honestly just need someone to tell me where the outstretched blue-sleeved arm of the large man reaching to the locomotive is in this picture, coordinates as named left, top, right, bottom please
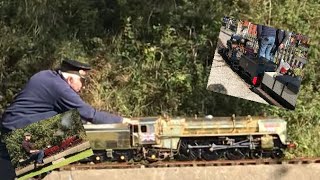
left=57, top=88, right=123, bottom=124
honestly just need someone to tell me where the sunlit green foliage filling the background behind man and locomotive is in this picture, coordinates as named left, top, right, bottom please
left=0, top=0, right=320, bottom=156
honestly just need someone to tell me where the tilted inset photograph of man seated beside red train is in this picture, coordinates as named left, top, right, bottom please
left=5, top=110, right=93, bottom=179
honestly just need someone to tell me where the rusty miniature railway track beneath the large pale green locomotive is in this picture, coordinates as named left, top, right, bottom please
left=59, top=158, right=320, bottom=171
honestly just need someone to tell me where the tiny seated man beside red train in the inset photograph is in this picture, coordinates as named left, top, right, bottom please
left=22, top=132, right=44, bottom=166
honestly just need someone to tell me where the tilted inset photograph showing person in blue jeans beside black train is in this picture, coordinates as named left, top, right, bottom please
left=207, top=17, right=310, bottom=110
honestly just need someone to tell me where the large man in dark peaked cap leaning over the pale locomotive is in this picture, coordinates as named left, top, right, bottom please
left=0, top=59, right=130, bottom=179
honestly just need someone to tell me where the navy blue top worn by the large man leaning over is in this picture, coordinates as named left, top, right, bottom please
left=2, top=70, right=122, bottom=130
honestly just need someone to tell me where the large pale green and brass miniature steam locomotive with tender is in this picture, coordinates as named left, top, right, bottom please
left=84, top=116, right=292, bottom=162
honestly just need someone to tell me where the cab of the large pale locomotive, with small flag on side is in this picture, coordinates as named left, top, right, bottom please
left=130, top=118, right=157, bottom=146
